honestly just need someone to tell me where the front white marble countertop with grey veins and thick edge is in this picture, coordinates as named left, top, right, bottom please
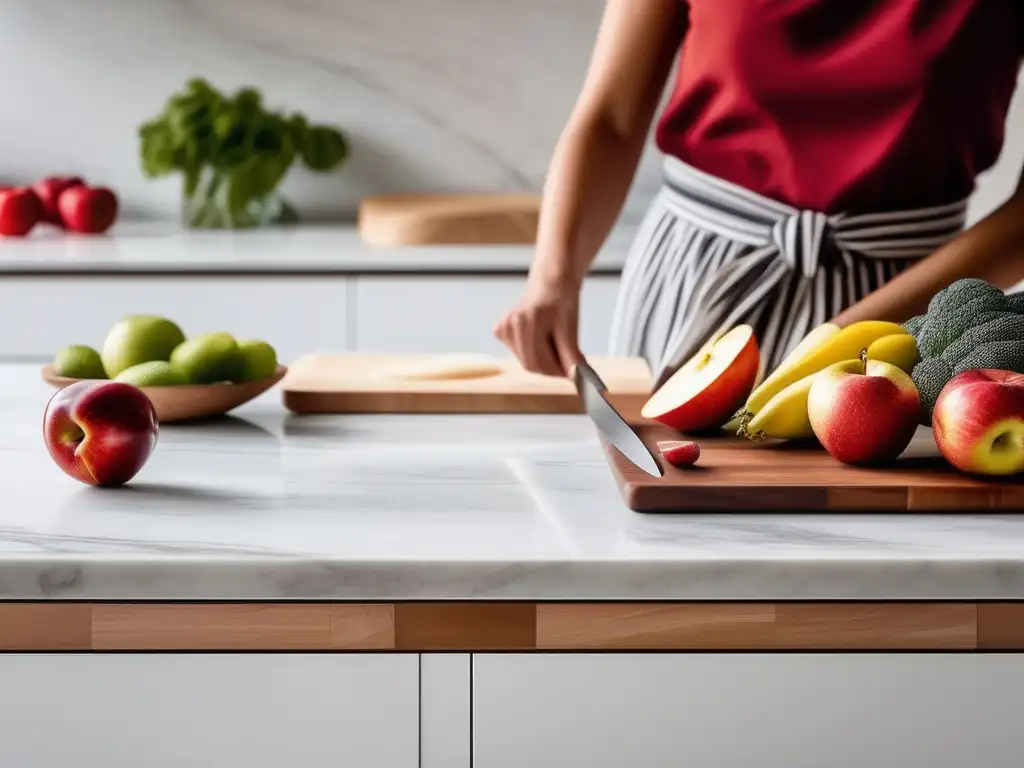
left=6, top=366, right=1024, bottom=600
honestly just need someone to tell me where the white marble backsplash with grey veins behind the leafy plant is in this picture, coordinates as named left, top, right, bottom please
left=0, top=0, right=1024, bottom=229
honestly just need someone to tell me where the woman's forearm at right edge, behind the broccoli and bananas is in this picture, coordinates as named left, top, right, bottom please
left=833, top=166, right=1024, bottom=327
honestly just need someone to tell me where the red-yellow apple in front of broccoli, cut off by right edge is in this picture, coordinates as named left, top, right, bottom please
left=932, top=369, right=1024, bottom=475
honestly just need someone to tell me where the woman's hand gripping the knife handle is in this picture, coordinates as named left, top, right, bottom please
left=495, top=278, right=583, bottom=376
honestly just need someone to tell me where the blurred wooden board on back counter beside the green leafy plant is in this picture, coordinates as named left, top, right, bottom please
left=358, top=195, right=541, bottom=246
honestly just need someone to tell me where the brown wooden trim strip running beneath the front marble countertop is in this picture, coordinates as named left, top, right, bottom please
left=0, top=601, right=1024, bottom=652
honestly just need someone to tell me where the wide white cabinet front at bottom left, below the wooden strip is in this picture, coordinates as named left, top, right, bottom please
left=0, top=654, right=419, bottom=768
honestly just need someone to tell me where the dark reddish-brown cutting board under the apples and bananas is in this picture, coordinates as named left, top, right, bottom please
left=605, top=425, right=1024, bottom=512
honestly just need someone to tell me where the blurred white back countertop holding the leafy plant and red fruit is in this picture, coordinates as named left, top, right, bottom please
left=0, top=223, right=632, bottom=275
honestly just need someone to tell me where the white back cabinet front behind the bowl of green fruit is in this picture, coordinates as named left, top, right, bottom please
left=0, top=275, right=349, bottom=364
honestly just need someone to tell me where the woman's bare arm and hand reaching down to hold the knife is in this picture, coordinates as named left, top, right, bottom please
left=495, top=0, right=686, bottom=376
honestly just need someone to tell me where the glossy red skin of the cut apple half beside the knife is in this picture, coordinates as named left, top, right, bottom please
left=645, top=333, right=761, bottom=432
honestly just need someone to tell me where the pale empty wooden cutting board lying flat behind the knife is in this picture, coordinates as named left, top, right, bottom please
left=281, top=354, right=651, bottom=419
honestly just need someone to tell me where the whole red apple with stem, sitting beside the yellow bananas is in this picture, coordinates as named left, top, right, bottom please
left=807, top=360, right=921, bottom=464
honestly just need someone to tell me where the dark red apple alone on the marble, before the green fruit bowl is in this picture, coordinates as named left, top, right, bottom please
left=43, top=381, right=159, bottom=485
